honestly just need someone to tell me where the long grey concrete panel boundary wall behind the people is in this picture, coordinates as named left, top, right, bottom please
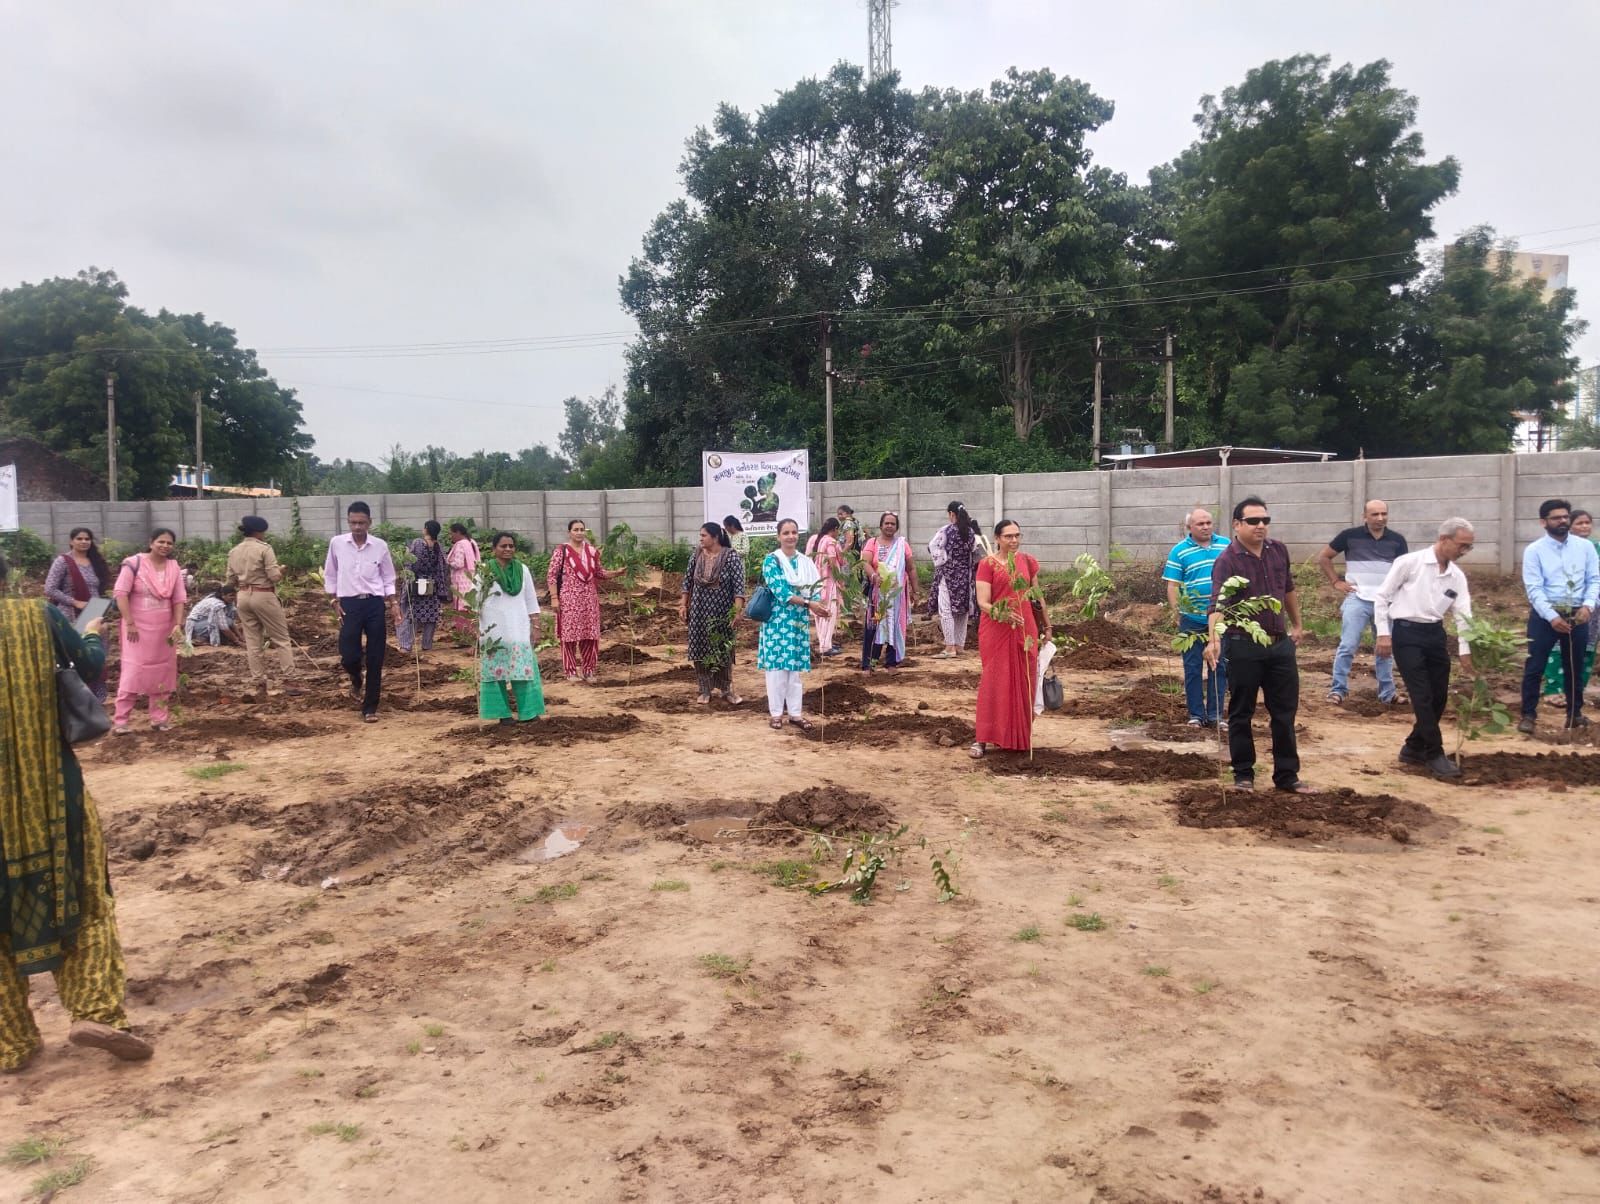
left=21, top=452, right=1600, bottom=572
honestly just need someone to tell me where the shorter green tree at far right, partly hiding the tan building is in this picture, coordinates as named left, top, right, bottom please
left=1401, top=226, right=1587, bottom=455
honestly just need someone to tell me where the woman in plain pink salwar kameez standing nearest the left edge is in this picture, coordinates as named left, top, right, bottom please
left=112, top=527, right=189, bottom=736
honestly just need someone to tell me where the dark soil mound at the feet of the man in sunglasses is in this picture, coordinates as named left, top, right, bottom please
left=1171, top=786, right=1443, bottom=844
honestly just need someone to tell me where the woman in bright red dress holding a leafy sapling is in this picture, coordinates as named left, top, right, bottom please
left=971, top=519, right=1050, bottom=757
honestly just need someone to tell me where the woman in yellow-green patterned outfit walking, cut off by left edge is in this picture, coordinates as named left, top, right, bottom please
left=0, top=557, right=150, bottom=1071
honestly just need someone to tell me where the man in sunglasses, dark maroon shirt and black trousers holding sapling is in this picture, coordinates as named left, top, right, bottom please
left=1205, top=498, right=1315, bottom=794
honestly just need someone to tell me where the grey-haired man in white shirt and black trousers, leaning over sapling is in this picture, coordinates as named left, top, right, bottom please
left=1373, top=519, right=1475, bottom=778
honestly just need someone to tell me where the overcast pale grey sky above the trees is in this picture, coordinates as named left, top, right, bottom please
left=0, top=0, right=1600, bottom=461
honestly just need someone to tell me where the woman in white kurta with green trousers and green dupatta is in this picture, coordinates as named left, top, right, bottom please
left=478, top=532, right=544, bottom=724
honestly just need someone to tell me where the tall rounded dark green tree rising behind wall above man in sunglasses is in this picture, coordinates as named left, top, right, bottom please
left=1149, top=54, right=1459, bottom=455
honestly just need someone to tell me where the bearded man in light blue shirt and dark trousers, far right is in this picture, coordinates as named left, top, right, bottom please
left=1517, top=498, right=1600, bottom=735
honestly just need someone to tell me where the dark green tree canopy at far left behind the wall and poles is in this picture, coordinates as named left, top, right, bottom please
left=0, top=267, right=310, bottom=498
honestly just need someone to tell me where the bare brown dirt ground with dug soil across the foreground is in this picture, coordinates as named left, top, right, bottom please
left=0, top=585, right=1600, bottom=1204
